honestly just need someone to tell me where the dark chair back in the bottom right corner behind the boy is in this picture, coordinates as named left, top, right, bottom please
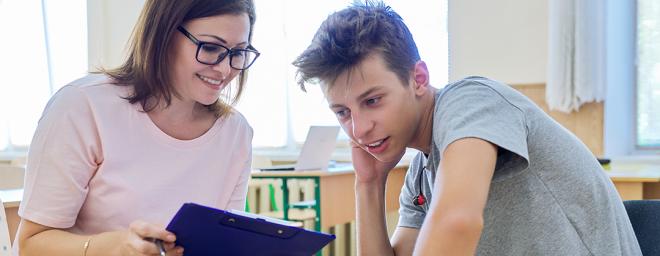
left=623, top=200, right=660, bottom=255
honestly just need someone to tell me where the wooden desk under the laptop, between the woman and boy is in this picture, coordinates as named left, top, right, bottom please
left=252, top=164, right=408, bottom=230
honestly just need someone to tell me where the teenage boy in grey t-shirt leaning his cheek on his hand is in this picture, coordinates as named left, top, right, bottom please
left=294, top=2, right=641, bottom=255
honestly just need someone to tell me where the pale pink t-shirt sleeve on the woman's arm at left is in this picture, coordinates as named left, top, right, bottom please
left=19, top=86, right=102, bottom=228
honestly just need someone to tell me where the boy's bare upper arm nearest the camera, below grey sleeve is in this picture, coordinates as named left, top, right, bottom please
left=415, top=138, right=497, bottom=255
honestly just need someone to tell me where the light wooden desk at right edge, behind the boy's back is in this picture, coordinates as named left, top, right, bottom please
left=607, top=166, right=660, bottom=200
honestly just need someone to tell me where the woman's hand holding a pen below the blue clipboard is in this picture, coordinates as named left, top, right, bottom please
left=119, top=220, right=183, bottom=256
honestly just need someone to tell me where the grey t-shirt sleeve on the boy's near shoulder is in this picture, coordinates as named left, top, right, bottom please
left=433, top=81, right=529, bottom=179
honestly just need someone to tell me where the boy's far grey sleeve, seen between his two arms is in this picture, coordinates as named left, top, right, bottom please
left=397, top=153, right=426, bottom=229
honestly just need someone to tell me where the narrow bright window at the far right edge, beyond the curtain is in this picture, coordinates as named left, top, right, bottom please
left=636, top=0, right=660, bottom=149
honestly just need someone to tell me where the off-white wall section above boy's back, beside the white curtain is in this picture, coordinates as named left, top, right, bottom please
left=448, top=0, right=548, bottom=84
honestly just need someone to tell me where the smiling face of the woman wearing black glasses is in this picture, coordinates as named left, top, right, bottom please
left=172, top=14, right=250, bottom=105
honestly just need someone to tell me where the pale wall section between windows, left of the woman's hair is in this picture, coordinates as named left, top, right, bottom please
left=87, top=0, right=144, bottom=71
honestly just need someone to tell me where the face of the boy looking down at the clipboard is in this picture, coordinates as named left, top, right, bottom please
left=322, top=54, right=420, bottom=162
